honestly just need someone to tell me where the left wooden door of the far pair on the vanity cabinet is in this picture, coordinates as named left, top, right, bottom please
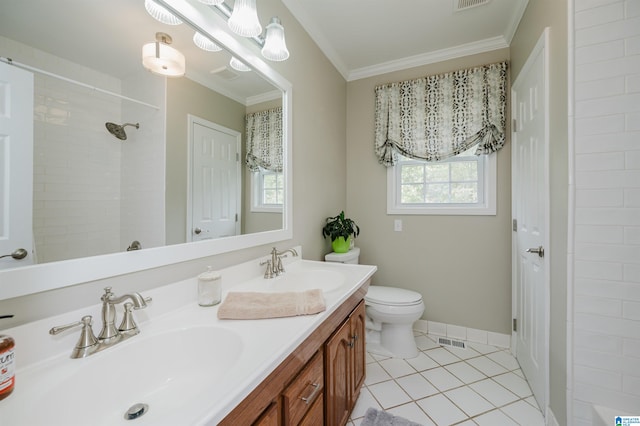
left=325, top=321, right=353, bottom=426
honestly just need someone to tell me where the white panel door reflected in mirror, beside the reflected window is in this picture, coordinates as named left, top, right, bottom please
left=187, top=117, right=241, bottom=241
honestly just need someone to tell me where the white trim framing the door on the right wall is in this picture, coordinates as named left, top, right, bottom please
left=511, top=27, right=551, bottom=419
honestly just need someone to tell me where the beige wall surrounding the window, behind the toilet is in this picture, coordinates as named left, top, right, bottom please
left=346, top=49, right=511, bottom=333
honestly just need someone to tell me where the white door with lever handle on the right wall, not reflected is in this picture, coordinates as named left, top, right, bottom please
left=511, top=30, right=549, bottom=413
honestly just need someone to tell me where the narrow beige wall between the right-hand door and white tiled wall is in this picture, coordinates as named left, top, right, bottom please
left=511, top=0, right=568, bottom=425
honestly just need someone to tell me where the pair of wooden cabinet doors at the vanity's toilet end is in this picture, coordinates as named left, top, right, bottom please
left=325, top=302, right=365, bottom=425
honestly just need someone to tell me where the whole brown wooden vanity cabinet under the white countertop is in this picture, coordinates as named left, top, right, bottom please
left=219, top=282, right=369, bottom=426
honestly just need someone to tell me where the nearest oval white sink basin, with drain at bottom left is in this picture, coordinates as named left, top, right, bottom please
left=10, top=326, right=243, bottom=426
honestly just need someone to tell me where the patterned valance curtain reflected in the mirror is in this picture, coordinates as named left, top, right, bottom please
left=245, top=107, right=282, bottom=172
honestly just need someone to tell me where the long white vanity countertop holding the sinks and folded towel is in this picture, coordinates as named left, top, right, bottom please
left=0, top=251, right=377, bottom=426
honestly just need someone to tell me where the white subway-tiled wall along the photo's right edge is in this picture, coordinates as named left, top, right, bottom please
left=568, top=0, right=640, bottom=425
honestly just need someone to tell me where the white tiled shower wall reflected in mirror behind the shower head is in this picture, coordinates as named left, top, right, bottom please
left=0, top=37, right=165, bottom=263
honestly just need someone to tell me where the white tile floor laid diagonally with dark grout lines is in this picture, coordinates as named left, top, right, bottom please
left=347, top=332, right=544, bottom=426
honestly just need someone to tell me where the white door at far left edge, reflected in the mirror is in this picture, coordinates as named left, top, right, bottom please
left=0, top=62, right=33, bottom=269
